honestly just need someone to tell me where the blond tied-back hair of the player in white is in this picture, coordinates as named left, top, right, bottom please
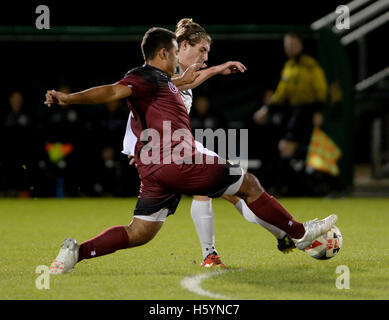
left=176, top=18, right=212, bottom=46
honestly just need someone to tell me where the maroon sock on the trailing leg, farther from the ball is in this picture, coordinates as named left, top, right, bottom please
left=78, top=226, right=128, bottom=261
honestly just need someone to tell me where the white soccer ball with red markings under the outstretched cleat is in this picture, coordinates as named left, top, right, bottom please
left=305, top=226, right=343, bottom=260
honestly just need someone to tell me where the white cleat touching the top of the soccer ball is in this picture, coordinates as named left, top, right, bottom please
left=293, top=214, right=338, bottom=250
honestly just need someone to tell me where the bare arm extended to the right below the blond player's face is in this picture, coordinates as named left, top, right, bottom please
left=176, top=61, right=247, bottom=90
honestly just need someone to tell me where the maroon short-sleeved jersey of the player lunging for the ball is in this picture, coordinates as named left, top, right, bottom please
left=117, top=65, right=196, bottom=179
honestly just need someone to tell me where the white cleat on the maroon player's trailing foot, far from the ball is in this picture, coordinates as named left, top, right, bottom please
left=50, top=238, right=80, bottom=274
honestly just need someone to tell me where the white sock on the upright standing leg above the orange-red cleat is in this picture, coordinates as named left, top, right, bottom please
left=190, top=199, right=217, bottom=259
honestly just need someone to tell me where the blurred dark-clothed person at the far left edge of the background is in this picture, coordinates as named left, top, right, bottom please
left=0, top=91, right=35, bottom=197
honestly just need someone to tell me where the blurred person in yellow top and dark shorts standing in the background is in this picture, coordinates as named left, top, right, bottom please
left=253, top=33, right=327, bottom=195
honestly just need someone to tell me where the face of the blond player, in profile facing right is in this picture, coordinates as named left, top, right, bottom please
left=178, top=39, right=211, bottom=68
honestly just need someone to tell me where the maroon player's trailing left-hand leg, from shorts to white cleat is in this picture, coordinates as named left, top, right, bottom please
left=50, top=175, right=180, bottom=274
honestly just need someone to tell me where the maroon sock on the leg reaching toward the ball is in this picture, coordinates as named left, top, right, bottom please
left=248, top=192, right=305, bottom=239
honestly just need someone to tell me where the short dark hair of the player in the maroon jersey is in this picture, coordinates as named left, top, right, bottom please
left=141, top=27, right=176, bottom=61
